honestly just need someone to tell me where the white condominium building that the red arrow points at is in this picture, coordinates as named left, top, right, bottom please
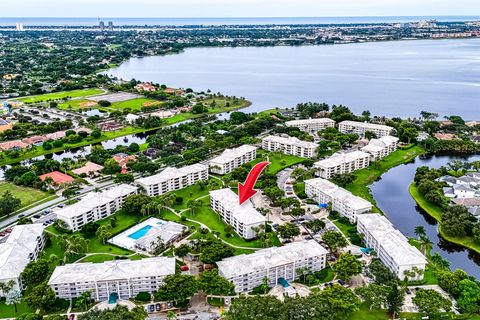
left=210, top=189, right=267, bottom=239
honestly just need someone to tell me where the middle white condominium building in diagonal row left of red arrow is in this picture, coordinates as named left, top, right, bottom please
left=136, top=163, right=208, bottom=196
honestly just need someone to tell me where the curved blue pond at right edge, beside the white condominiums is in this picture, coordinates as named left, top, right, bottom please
left=371, top=156, right=480, bottom=279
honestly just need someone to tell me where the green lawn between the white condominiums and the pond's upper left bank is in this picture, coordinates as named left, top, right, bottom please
left=346, top=145, right=425, bottom=212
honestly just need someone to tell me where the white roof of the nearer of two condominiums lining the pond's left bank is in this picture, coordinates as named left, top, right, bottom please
left=357, top=213, right=427, bottom=265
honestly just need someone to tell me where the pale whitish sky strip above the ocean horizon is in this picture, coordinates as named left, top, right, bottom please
left=0, top=0, right=480, bottom=20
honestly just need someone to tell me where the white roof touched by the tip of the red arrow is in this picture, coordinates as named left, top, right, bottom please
left=210, top=188, right=267, bottom=225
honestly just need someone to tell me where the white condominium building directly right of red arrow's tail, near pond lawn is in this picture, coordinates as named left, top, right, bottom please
left=313, top=151, right=370, bottom=179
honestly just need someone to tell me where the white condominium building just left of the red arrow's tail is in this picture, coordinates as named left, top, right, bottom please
left=208, top=145, right=257, bottom=174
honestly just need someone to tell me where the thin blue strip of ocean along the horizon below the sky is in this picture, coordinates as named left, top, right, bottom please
left=0, top=15, right=480, bottom=26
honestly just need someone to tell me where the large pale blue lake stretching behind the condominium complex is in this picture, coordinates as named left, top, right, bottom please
left=108, top=39, right=480, bottom=120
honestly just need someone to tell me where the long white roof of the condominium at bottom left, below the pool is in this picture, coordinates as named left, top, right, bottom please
left=48, top=257, right=175, bottom=285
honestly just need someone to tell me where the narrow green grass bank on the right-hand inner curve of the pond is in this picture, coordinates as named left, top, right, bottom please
left=409, top=183, right=480, bottom=253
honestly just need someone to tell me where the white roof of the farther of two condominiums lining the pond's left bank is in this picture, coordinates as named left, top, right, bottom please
left=305, top=178, right=373, bottom=210
